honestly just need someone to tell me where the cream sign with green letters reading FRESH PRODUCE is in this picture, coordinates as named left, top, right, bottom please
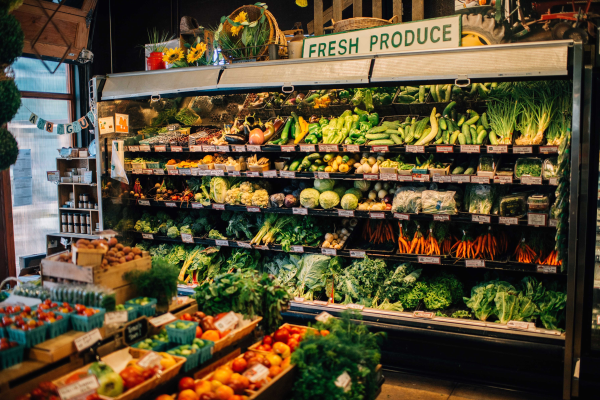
left=302, top=15, right=461, bottom=58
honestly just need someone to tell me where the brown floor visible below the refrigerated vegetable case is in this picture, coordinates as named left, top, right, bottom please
left=377, top=371, right=554, bottom=400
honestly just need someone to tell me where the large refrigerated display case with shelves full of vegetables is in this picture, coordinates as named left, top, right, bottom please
left=90, top=41, right=600, bottom=398
